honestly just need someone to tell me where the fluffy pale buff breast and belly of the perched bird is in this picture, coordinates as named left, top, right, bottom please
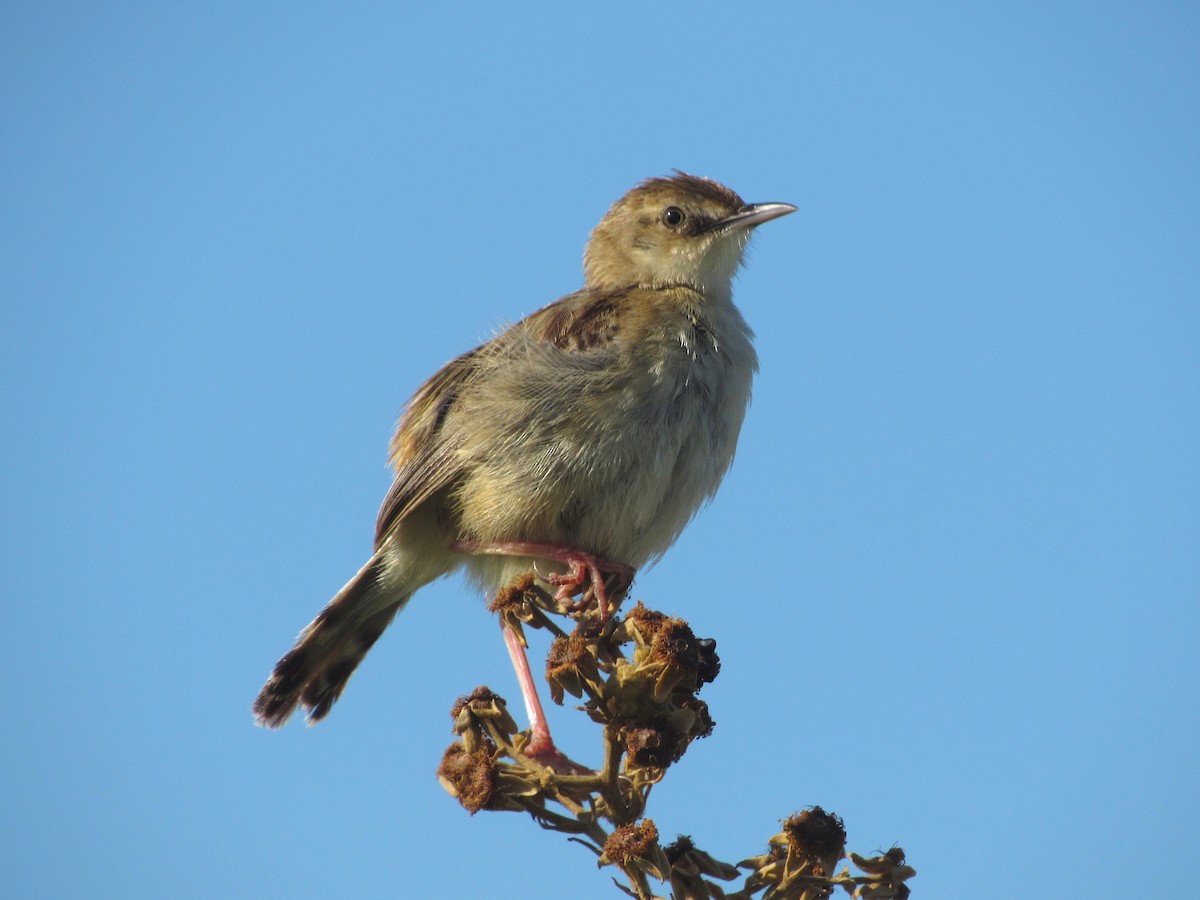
left=446, top=296, right=756, bottom=578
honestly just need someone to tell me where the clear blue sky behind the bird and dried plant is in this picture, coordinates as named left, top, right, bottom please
left=0, top=2, right=1200, bottom=898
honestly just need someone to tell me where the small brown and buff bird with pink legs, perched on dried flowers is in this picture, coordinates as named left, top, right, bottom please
left=253, top=170, right=797, bottom=766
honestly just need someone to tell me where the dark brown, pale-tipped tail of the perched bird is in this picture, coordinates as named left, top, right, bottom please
left=254, top=552, right=412, bottom=728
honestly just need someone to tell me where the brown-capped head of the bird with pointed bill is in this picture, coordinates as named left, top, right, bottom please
left=583, top=172, right=796, bottom=296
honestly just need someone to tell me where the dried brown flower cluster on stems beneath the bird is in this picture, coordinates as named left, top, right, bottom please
left=438, top=575, right=916, bottom=900
